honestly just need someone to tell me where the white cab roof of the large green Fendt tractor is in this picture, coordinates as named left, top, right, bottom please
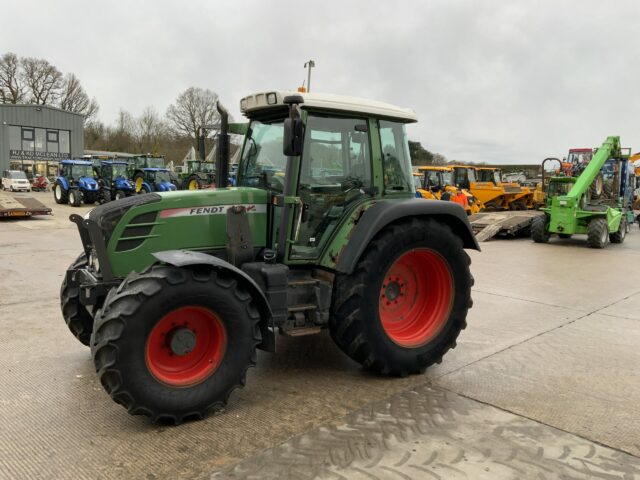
left=240, top=90, right=418, bottom=123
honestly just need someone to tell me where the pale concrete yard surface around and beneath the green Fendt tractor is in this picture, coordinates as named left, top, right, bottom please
left=0, top=192, right=640, bottom=480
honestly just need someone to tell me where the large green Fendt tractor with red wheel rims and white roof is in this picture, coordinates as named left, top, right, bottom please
left=61, top=92, right=479, bottom=423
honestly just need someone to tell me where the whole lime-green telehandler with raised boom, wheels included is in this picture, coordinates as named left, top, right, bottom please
left=531, top=136, right=634, bottom=248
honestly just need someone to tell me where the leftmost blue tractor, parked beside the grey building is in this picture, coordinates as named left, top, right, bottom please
left=53, top=160, right=100, bottom=207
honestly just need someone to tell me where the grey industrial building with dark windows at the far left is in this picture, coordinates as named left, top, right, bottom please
left=0, top=104, right=84, bottom=177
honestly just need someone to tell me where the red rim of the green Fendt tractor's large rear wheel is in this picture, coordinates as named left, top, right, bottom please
left=378, top=249, right=454, bottom=348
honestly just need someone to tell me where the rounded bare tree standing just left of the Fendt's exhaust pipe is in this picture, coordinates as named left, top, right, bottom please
left=167, top=87, right=220, bottom=148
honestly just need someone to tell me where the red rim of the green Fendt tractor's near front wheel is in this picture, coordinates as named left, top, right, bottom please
left=146, top=306, right=227, bottom=387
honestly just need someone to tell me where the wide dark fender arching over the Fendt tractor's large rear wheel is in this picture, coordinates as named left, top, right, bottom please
left=336, top=198, right=480, bottom=274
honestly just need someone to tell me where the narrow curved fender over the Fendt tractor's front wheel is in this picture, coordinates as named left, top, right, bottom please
left=152, top=250, right=276, bottom=352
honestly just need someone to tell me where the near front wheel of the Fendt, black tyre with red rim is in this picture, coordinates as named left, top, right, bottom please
left=91, top=265, right=261, bottom=424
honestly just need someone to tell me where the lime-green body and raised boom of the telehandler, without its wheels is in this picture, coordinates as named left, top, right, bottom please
left=540, top=136, right=625, bottom=235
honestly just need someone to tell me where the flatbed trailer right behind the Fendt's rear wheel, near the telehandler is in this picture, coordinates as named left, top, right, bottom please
left=469, top=210, right=544, bottom=242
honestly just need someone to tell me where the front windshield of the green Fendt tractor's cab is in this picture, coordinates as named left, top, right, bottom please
left=238, top=119, right=286, bottom=192
